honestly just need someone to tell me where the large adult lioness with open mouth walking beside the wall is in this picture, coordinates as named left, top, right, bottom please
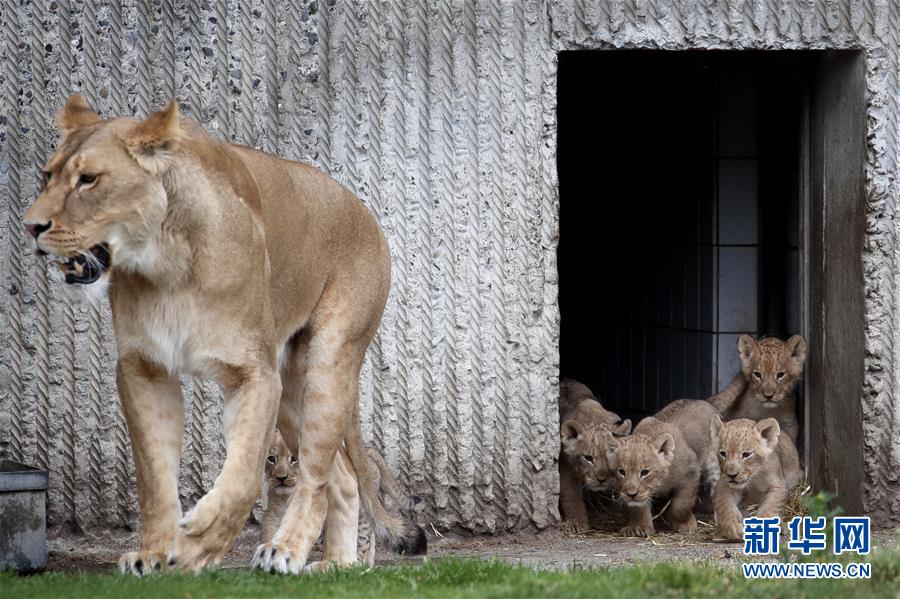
left=24, top=95, right=424, bottom=574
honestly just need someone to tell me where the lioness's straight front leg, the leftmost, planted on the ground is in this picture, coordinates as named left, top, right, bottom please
left=116, top=356, right=184, bottom=576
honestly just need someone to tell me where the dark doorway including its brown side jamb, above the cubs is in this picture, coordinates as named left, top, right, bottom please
left=557, top=50, right=865, bottom=513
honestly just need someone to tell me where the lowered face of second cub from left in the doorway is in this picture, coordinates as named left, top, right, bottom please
left=606, top=426, right=675, bottom=506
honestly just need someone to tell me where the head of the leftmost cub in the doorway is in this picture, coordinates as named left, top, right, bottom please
left=559, top=419, right=631, bottom=491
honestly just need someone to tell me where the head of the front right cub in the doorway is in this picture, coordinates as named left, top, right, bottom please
left=710, top=414, right=781, bottom=489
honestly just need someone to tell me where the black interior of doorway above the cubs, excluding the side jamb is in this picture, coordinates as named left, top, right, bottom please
left=558, top=51, right=806, bottom=424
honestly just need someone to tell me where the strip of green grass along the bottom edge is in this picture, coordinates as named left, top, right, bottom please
left=0, top=551, right=900, bottom=599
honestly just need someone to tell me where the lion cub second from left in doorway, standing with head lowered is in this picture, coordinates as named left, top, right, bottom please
left=606, top=399, right=718, bottom=537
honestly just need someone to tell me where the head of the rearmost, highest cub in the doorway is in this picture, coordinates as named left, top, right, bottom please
left=738, top=335, right=806, bottom=408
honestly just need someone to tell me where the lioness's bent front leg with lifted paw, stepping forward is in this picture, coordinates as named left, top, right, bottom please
left=169, top=364, right=281, bottom=571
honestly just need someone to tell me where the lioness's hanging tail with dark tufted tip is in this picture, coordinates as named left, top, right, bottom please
left=344, top=407, right=428, bottom=555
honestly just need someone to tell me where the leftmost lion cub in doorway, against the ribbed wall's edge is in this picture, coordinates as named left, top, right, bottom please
left=559, top=379, right=631, bottom=532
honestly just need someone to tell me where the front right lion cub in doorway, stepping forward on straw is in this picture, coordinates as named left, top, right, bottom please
left=710, top=415, right=800, bottom=540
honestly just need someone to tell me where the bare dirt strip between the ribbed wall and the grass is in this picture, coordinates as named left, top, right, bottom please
left=47, top=521, right=900, bottom=572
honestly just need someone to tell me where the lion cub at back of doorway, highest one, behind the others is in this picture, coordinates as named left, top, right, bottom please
left=709, top=335, right=806, bottom=445
